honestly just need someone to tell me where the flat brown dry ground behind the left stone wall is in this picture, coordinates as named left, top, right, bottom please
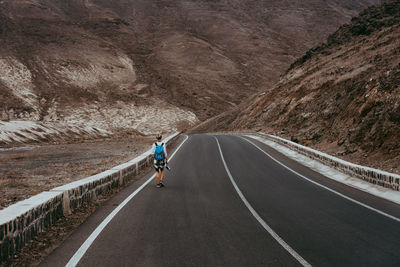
left=0, top=136, right=153, bottom=209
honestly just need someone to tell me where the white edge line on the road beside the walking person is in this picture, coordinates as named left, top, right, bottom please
left=65, top=136, right=189, bottom=267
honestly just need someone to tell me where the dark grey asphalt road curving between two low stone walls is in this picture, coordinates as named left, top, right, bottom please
left=42, top=135, right=400, bottom=266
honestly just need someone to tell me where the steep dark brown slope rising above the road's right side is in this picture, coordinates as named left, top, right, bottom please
left=197, top=1, right=400, bottom=172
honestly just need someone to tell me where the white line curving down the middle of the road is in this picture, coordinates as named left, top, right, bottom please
left=214, top=136, right=311, bottom=266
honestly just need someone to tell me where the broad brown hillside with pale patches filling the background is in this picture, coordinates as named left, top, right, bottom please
left=0, top=0, right=380, bottom=142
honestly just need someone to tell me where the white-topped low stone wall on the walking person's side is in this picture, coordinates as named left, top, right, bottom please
left=0, top=133, right=179, bottom=263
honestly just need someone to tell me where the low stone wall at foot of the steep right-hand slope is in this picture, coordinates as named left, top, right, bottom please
left=257, top=132, right=400, bottom=191
